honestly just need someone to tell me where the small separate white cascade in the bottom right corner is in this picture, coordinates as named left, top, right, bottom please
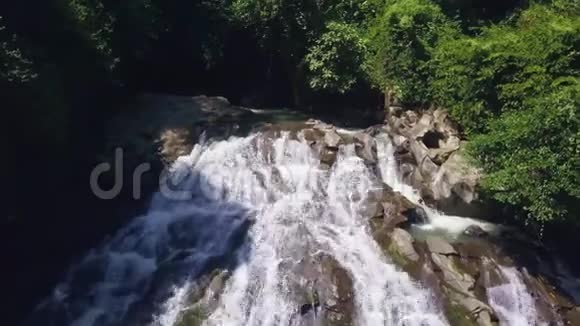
left=487, top=266, right=546, bottom=326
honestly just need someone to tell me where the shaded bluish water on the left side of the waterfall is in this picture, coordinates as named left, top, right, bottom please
left=23, top=167, right=252, bottom=326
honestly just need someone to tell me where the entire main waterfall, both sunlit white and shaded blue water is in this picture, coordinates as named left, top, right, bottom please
left=29, top=132, right=447, bottom=326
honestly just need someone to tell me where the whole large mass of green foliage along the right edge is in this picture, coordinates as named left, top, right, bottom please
left=433, top=2, right=580, bottom=223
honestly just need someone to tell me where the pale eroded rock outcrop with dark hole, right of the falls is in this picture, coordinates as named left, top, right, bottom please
left=385, top=108, right=487, bottom=217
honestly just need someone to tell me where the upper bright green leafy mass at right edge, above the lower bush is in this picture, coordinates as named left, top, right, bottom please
left=433, top=2, right=580, bottom=132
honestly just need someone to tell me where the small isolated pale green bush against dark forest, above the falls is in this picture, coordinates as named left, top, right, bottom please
left=306, top=22, right=366, bottom=93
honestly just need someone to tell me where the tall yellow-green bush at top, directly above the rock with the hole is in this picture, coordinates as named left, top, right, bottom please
left=369, top=0, right=457, bottom=103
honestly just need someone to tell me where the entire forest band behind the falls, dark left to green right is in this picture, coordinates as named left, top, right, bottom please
left=0, top=0, right=580, bottom=227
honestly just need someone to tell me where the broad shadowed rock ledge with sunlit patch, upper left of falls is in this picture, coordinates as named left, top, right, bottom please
left=98, top=94, right=255, bottom=202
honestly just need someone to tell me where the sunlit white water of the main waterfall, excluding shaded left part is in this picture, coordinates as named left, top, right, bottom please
left=152, top=133, right=446, bottom=326
